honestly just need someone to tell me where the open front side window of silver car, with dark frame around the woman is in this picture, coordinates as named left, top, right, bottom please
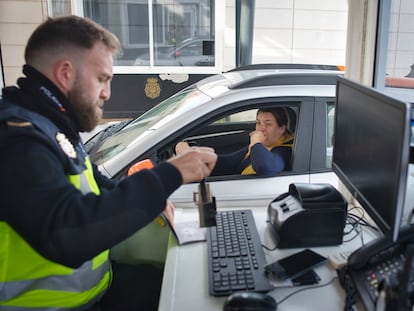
left=114, top=97, right=315, bottom=181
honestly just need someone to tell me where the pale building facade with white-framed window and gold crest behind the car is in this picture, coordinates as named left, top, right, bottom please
left=0, top=0, right=414, bottom=118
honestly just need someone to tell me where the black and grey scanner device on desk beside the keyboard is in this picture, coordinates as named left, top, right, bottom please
left=267, top=183, right=348, bottom=248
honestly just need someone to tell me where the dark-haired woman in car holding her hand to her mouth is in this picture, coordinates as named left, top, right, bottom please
left=175, top=107, right=293, bottom=176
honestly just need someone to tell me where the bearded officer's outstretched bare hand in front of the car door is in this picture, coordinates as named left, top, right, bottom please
left=168, top=147, right=217, bottom=184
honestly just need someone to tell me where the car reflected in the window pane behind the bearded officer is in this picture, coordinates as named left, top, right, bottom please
left=134, top=37, right=214, bottom=66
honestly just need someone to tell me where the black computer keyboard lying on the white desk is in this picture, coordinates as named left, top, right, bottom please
left=207, top=210, right=272, bottom=296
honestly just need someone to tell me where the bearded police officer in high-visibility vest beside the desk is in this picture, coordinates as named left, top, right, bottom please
left=0, top=16, right=216, bottom=310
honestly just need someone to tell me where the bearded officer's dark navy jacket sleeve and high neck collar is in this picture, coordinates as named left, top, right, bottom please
left=0, top=66, right=182, bottom=267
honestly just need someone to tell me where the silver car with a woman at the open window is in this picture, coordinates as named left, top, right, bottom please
left=86, top=65, right=343, bottom=208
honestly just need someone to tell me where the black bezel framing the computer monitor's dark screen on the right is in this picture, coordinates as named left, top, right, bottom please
left=332, top=76, right=411, bottom=241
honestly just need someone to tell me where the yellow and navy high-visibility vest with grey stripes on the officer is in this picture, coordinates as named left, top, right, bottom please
left=0, top=103, right=111, bottom=311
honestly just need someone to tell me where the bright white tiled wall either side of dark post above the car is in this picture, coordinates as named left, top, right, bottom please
left=223, top=0, right=348, bottom=70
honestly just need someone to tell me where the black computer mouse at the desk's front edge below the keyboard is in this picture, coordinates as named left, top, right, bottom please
left=223, top=292, right=277, bottom=311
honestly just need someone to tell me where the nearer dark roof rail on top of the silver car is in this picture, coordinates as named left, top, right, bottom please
left=228, top=73, right=341, bottom=89
